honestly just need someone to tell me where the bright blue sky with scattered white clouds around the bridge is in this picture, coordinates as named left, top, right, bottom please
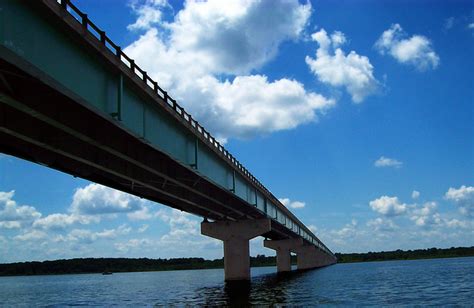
left=0, top=0, right=474, bottom=262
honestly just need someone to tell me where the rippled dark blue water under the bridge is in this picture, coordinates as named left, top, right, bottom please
left=0, top=258, right=474, bottom=306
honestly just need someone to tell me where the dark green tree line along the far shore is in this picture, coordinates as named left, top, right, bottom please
left=0, top=247, right=474, bottom=276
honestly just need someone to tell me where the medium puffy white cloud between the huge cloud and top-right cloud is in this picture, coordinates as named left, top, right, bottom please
left=306, top=29, right=378, bottom=103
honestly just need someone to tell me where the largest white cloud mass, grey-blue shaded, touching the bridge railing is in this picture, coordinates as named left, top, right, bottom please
left=125, top=0, right=335, bottom=142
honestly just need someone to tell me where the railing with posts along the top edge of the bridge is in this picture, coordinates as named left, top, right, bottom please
left=56, top=0, right=335, bottom=258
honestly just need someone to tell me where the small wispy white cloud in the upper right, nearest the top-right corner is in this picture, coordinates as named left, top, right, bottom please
left=375, top=24, right=439, bottom=71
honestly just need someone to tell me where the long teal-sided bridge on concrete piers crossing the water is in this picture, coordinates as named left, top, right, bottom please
left=0, top=0, right=336, bottom=280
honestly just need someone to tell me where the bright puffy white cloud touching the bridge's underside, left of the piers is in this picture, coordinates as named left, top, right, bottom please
left=70, top=183, right=145, bottom=215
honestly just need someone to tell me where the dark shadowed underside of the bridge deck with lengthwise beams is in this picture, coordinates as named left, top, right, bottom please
left=0, top=47, right=297, bottom=239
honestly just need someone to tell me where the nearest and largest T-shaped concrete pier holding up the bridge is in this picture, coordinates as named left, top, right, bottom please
left=201, top=218, right=271, bottom=281
